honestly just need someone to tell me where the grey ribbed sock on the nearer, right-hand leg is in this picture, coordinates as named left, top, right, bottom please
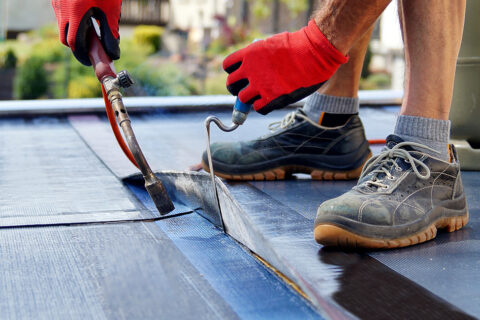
left=394, top=115, right=450, bottom=161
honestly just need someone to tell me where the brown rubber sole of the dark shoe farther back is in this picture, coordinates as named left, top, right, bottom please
left=202, top=153, right=372, bottom=181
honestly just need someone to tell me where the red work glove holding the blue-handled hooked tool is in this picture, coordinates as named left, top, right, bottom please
left=223, top=20, right=348, bottom=114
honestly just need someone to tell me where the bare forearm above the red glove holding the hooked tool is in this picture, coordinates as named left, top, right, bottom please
left=315, top=0, right=391, bottom=54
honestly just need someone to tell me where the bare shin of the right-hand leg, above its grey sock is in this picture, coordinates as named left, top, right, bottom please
left=398, top=0, right=465, bottom=120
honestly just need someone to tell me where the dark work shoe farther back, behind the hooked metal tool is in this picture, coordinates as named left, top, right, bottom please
left=202, top=109, right=371, bottom=180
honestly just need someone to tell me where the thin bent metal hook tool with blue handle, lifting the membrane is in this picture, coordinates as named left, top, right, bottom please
left=205, top=98, right=252, bottom=213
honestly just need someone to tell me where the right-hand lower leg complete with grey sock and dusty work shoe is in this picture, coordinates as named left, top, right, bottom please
left=314, top=0, right=468, bottom=248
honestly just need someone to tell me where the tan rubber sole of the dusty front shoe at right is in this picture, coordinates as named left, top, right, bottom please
left=314, top=212, right=468, bottom=249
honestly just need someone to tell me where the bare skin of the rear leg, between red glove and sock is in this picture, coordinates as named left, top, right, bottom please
left=318, top=25, right=373, bottom=98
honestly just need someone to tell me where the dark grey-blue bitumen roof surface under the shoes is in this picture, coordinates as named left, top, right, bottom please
left=0, top=104, right=480, bottom=319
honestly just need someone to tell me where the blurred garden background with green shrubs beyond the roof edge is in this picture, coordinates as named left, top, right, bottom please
left=0, top=0, right=404, bottom=99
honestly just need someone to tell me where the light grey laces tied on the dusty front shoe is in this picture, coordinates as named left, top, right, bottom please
left=359, top=142, right=439, bottom=189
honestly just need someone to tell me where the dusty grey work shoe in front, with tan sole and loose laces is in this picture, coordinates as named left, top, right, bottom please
left=314, top=135, right=468, bottom=248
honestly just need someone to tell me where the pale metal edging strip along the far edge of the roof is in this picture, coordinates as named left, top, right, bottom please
left=0, top=90, right=403, bottom=116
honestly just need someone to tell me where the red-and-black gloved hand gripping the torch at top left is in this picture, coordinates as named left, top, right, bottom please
left=52, top=0, right=122, bottom=66
